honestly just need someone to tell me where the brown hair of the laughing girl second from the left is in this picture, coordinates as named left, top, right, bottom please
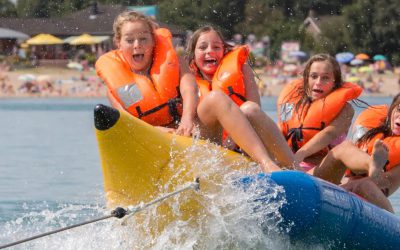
left=186, top=25, right=233, bottom=76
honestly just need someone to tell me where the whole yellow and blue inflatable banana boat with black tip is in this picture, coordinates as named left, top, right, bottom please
left=95, top=105, right=400, bottom=249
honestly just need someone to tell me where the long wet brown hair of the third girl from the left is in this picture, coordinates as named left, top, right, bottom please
left=295, top=54, right=343, bottom=111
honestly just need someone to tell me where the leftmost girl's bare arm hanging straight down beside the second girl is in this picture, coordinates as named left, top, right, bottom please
left=176, top=59, right=199, bottom=136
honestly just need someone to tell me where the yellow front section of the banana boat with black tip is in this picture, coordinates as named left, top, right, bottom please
left=94, top=104, right=251, bottom=221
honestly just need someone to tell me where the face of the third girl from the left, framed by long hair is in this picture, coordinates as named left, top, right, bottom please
left=308, top=61, right=335, bottom=101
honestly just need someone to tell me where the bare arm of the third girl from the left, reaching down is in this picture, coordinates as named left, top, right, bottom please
left=294, top=103, right=354, bottom=164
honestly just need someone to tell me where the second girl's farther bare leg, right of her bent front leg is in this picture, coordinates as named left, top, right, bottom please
left=240, top=101, right=294, bottom=168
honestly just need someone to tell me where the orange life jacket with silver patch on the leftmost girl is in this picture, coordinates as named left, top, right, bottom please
left=96, top=29, right=182, bottom=126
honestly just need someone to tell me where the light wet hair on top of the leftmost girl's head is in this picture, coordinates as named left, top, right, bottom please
left=113, top=11, right=158, bottom=46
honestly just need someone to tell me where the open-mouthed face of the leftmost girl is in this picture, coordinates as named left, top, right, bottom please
left=118, top=21, right=155, bottom=73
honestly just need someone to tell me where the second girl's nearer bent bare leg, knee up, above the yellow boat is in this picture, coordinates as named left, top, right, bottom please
left=197, top=91, right=281, bottom=172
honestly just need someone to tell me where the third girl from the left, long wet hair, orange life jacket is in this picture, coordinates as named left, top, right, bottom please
left=277, top=54, right=362, bottom=174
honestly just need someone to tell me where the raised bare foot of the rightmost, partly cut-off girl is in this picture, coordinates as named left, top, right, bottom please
left=368, top=140, right=389, bottom=179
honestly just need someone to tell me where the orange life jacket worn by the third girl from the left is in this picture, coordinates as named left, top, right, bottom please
left=277, top=79, right=362, bottom=152
